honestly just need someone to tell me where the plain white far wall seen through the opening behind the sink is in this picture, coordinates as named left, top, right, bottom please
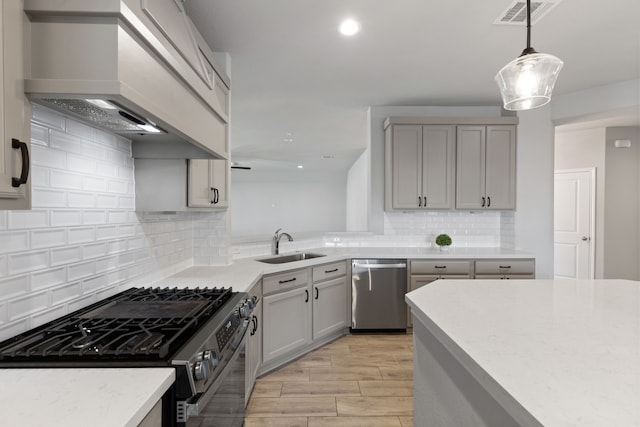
left=229, top=169, right=347, bottom=239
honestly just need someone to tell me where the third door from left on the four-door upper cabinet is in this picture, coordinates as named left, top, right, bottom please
left=456, top=126, right=486, bottom=209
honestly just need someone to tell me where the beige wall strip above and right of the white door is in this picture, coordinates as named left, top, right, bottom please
left=555, top=127, right=605, bottom=279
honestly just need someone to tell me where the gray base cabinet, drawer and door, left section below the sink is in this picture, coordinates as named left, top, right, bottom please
left=262, top=269, right=312, bottom=366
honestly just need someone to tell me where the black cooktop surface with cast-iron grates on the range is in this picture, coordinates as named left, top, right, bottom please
left=0, top=288, right=233, bottom=366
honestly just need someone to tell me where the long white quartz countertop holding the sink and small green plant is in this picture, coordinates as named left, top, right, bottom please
left=154, top=247, right=534, bottom=292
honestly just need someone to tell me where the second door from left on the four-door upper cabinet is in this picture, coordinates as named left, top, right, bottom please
left=422, top=126, right=455, bottom=209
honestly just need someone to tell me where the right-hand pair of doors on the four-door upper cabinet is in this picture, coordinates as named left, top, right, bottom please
left=456, top=125, right=516, bottom=210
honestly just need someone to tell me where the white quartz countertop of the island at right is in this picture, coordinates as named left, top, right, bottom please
left=406, top=280, right=640, bottom=427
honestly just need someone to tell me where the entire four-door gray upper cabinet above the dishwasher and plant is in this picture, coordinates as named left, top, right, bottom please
left=384, top=117, right=518, bottom=210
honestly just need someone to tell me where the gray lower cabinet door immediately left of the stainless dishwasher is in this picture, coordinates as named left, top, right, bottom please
left=313, top=276, right=347, bottom=340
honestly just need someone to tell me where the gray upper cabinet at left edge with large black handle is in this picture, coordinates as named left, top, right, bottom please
left=0, top=0, right=31, bottom=210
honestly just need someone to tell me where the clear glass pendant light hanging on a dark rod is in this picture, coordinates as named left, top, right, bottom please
left=495, top=0, right=564, bottom=111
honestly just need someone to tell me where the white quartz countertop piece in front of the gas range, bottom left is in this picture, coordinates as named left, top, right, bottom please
left=0, top=368, right=175, bottom=427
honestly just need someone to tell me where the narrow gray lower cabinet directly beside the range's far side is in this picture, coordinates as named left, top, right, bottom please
left=244, top=282, right=262, bottom=406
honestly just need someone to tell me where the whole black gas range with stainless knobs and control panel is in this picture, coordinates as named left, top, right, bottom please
left=0, top=288, right=256, bottom=426
